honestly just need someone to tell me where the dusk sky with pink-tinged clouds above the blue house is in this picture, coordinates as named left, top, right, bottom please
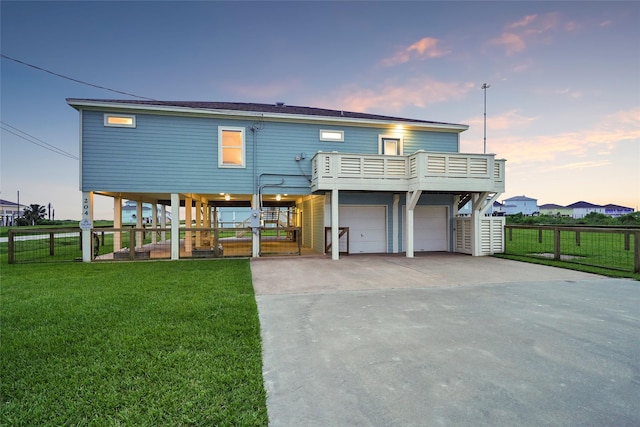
left=0, top=1, right=640, bottom=219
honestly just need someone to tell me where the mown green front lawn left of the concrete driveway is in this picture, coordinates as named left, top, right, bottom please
left=0, top=258, right=267, bottom=426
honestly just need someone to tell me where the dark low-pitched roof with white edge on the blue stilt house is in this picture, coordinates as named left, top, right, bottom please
left=67, top=98, right=469, bottom=132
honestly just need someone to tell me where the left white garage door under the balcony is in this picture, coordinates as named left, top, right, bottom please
left=338, top=206, right=387, bottom=254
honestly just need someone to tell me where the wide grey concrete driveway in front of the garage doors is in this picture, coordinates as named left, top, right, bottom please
left=251, top=254, right=640, bottom=427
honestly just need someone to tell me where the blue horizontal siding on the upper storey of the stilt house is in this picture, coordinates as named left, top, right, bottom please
left=82, top=110, right=458, bottom=194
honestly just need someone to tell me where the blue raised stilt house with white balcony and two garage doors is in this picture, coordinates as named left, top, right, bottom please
left=67, top=99, right=505, bottom=261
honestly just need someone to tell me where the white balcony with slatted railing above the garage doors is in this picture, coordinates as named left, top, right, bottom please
left=311, top=151, right=505, bottom=193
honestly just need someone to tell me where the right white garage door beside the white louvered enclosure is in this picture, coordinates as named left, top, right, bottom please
left=403, top=206, right=449, bottom=252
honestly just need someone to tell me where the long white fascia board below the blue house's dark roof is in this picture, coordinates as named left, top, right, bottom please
left=67, top=99, right=469, bottom=132
